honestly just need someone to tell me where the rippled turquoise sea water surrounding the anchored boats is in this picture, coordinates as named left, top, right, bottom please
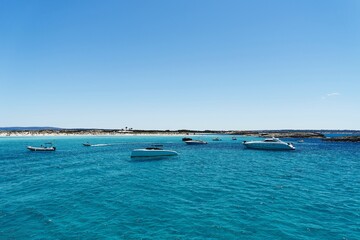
left=0, top=136, right=360, bottom=239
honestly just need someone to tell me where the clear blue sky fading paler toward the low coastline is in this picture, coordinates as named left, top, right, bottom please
left=0, top=0, right=360, bottom=129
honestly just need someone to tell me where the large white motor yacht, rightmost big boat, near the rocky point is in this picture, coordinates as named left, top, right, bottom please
left=243, top=137, right=295, bottom=150
